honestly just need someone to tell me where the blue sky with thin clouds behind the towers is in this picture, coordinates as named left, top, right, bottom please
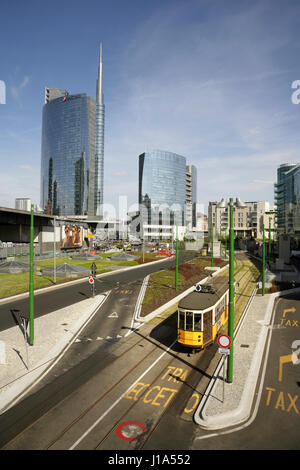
left=0, top=0, right=300, bottom=215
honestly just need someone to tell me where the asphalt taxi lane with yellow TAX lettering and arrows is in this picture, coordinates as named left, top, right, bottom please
left=193, top=294, right=300, bottom=450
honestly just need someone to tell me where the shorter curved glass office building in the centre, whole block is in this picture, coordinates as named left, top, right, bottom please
left=139, top=150, right=197, bottom=240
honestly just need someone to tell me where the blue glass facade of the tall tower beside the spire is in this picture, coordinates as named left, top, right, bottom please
left=41, top=94, right=96, bottom=215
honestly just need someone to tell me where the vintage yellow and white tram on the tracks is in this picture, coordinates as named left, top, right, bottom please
left=177, top=276, right=233, bottom=349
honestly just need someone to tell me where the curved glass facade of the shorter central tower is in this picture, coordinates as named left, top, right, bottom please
left=139, top=150, right=186, bottom=232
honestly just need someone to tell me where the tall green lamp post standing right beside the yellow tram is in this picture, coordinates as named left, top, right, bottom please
left=218, top=197, right=246, bottom=383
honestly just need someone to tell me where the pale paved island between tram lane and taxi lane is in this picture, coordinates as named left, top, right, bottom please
left=194, top=282, right=300, bottom=434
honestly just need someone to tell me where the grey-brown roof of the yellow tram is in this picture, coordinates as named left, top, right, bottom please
left=178, top=276, right=229, bottom=310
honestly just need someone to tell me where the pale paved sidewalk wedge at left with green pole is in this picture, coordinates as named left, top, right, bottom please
left=0, top=293, right=108, bottom=413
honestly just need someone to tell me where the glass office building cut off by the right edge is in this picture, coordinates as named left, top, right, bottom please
left=274, top=163, right=300, bottom=241
